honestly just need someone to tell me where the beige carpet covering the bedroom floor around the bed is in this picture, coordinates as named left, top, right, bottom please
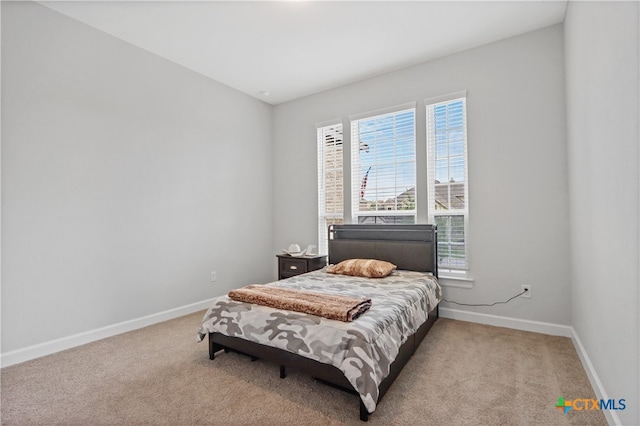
left=1, top=313, right=606, bottom=425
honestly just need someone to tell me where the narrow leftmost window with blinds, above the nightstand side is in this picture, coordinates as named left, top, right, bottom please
left=317, top=124, right=344, bottom=254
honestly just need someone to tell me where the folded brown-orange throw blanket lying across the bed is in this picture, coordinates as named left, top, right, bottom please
left=229, top=284, right=371, bottom=322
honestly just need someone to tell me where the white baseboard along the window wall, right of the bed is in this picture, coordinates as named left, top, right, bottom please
left=439, top=307, right=573, bottom=337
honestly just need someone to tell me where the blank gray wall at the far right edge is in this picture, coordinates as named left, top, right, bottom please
left=565, top=2, right=640, bottom=425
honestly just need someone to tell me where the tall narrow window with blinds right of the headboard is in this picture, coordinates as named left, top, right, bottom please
left=425, top=92, right=469, bottom=276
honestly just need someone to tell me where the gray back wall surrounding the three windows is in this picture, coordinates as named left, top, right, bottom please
left=273, top=25, right=571, bottom=325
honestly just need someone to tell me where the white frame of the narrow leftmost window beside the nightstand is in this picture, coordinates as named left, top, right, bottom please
left=316, top=120, right=345, bottom=254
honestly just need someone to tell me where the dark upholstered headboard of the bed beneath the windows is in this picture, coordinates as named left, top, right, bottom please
left=329, top=225, right=438, bottom=276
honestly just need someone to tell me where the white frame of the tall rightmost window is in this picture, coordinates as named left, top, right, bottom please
left=424, top=90, right=470, bottom=280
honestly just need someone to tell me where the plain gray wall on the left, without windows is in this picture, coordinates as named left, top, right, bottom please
left=2, top=2, right=275, bottom=353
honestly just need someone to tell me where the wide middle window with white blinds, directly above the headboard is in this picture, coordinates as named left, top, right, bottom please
left=351, top=104, right=416, bottom=223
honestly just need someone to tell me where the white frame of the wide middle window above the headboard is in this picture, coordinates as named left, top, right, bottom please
left=349, top=102, right=417, bottom=223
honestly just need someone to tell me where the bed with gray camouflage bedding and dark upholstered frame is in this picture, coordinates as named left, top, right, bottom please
left=198, top=225, right=441, bottom=421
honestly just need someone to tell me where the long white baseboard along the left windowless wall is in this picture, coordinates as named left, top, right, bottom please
left=0, top=299, right=213, bottom=367
